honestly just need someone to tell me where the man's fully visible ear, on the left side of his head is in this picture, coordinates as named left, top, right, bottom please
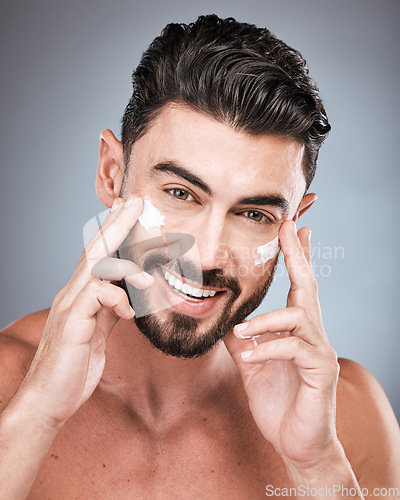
left=96, top=129, right=124, bottom=207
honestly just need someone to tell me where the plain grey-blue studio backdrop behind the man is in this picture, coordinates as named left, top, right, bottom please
left=0, top=0, right=400, bottom=418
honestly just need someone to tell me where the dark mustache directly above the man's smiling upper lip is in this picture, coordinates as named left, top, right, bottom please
left=143, top=252, right=242, bottom=300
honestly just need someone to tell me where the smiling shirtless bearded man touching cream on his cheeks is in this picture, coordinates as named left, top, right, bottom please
left=0, top=16, right=400, bottom=499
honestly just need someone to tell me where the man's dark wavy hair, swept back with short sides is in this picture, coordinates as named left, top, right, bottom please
left=122, top=15, right=331, bottom=189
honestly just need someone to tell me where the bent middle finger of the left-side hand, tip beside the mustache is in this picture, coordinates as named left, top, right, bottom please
left=89, top=257, right=154, bottom=289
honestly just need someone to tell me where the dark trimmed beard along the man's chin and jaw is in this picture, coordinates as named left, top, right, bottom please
left=135, top=259, right=278, bottom=359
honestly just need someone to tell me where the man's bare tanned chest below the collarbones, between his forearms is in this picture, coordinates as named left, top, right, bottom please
left=29, top=404, right=289, bottom=500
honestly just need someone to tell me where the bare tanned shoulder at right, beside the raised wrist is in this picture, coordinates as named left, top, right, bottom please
left=337, top=359, right=400, bottom=486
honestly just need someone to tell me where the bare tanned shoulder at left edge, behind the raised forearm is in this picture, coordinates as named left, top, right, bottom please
left=0, top=309, right=49, bottom=411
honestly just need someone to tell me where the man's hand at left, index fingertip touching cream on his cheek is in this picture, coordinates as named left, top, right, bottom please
left=16, top=197, right=154, bottom=428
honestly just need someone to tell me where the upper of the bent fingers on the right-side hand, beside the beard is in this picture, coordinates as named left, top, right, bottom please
left=233, top=306, right=330, bottom=350
